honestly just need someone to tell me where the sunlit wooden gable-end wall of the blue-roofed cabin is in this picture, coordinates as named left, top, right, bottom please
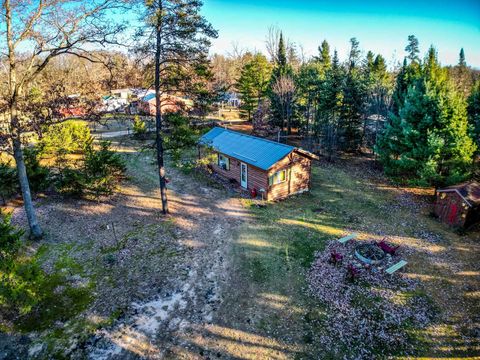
left=267, top=152, right=312, bottom=200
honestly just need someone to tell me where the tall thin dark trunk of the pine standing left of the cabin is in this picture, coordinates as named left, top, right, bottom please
left=155, top=16, right=168, bottom=214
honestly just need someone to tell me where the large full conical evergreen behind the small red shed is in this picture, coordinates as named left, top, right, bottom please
left=378, top=47, right=476, bottom=187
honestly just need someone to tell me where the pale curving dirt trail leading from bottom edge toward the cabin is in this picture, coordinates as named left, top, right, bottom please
left=87, top=168, right=246, bottom=360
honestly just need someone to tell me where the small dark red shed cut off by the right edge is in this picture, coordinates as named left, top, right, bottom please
left=435, top=181, right=480, bottom=228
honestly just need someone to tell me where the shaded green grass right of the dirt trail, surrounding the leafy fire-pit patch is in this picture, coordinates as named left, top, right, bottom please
left=224, top=159, right=480, bottom=358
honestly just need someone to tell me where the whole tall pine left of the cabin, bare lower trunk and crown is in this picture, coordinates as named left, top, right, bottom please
left=137, top=0, right=217, bottom=214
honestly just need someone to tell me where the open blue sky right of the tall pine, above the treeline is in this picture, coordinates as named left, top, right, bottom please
left=203, top=0, right=480, bottom=68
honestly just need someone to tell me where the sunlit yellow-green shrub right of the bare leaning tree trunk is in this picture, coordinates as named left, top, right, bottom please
left=39, top=120, right=91, bottom=156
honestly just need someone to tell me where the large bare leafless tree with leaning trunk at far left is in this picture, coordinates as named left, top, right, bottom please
left=0, top=0, right=124, bottom=238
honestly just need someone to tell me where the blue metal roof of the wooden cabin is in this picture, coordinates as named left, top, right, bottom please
left=200, top=127, right=295, bottom=170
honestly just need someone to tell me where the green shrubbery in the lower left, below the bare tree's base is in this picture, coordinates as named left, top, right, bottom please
left=0, top=212, right=91, bottom=331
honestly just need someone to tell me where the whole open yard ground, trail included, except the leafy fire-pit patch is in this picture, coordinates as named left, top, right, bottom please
left=0, top=139, right=480, bottom=359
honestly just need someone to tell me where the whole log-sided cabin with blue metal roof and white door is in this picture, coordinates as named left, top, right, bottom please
left=200, top=127, right=317, bottom=200
